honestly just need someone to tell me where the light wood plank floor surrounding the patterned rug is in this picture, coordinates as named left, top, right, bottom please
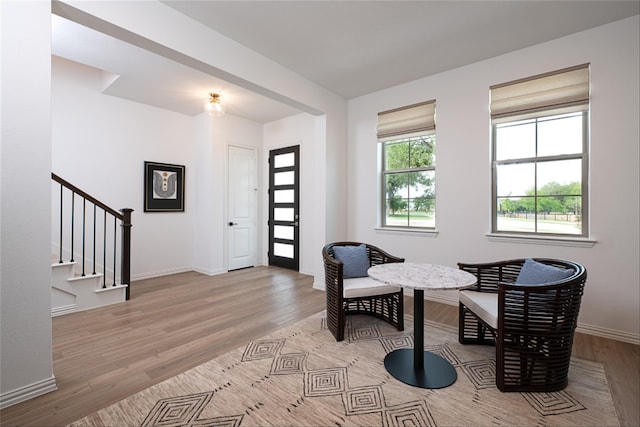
left=0, top=267, right=640, bottom=427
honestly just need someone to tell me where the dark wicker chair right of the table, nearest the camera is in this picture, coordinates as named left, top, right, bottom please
left=458, top=258, right=587, bottom=392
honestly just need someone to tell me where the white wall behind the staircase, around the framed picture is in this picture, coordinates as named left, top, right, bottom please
left=51, top=57, right=197, bottom=280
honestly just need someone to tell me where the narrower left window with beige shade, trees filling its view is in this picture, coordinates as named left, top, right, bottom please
left=378, top=101, right=436, bottom=228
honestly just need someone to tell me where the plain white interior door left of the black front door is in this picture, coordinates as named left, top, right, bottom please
left=227, top=146, right=258, bottom=270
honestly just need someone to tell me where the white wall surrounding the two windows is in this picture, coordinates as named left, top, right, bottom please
left=348, top=16, right=640, bottom=342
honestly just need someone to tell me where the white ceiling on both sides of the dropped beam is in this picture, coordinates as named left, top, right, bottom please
left=52, top=0, right=640, bottom=123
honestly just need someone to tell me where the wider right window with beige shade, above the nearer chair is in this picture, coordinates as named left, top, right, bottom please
left=491, top=65, right=589, bottom=237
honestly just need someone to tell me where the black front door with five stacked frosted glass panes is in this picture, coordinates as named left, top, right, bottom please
left=269, top=145, right=300, bottom=271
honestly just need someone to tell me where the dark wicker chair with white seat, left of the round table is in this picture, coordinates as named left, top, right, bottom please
left=322, top=242, right=404, bottom=341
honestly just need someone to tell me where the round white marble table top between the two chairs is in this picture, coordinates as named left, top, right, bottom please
left=367, top=262, right=476, bottom=290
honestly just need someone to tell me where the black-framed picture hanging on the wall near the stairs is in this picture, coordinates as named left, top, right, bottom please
left=144, top=162, right=185, bottom=212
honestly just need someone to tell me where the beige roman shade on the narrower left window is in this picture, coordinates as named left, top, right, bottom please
left=378, top=99, right=436, bottom=141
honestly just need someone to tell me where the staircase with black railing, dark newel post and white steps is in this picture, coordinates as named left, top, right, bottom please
left=51, top=173, right=133, bottom=316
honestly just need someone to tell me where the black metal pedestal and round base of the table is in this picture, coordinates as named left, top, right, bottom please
left=384, top=289, right=458, bottom=388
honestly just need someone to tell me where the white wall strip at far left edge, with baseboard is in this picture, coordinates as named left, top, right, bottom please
left=0, top=1, right=56, bottom=407
